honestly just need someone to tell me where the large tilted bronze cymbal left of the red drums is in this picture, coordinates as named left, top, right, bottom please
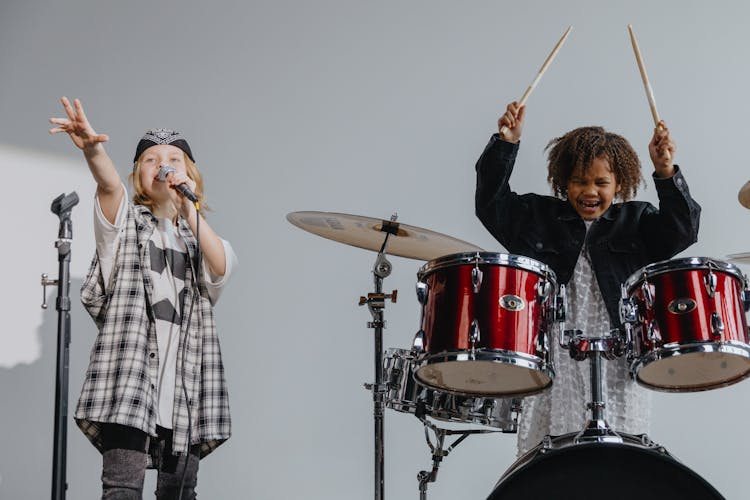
left=286, top=212, right=483, bottom=260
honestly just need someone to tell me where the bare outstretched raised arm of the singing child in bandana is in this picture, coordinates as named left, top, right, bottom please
left=49, top=97, right=124, bottom=223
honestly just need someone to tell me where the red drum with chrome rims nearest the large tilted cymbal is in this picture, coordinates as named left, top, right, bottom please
left=414, top=252, right=556, bottom=396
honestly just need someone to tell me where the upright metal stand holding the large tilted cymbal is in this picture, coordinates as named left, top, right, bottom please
left=359, top=214, right=398, bottom=500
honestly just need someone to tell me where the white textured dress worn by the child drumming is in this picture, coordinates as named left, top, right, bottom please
left=518, top=221, right=651, bottom=456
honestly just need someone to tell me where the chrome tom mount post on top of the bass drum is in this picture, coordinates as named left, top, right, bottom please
left=560, top=329, right=625, bottom=443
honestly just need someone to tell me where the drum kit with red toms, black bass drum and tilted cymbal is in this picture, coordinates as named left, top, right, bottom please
left=287, top=212, right=750, bottom=500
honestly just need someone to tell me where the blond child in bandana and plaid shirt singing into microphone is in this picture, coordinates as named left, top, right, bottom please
left=50, top=97, right=237, bottom=500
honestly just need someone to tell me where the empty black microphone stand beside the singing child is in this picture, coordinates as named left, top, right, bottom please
left=41, top=191, right=78, bottom=500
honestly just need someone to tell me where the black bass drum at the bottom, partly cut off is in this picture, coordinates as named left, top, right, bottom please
left=487, top=433, right=724, bottom=500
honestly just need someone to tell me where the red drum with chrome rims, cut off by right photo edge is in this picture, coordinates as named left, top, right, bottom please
left=623, top=257, right=750, bottom=392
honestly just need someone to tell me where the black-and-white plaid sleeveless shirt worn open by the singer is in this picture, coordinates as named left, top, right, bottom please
left=75, top=203, right=231, bottom=457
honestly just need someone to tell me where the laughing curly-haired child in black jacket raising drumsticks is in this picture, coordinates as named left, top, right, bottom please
left=475, top=102, right=701, bottom=455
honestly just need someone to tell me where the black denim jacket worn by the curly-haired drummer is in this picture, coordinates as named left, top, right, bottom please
left=475, top=134, right=701, bottom=327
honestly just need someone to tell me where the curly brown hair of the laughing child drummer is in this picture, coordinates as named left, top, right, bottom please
left=544, top=127, right=644, bottom=201
